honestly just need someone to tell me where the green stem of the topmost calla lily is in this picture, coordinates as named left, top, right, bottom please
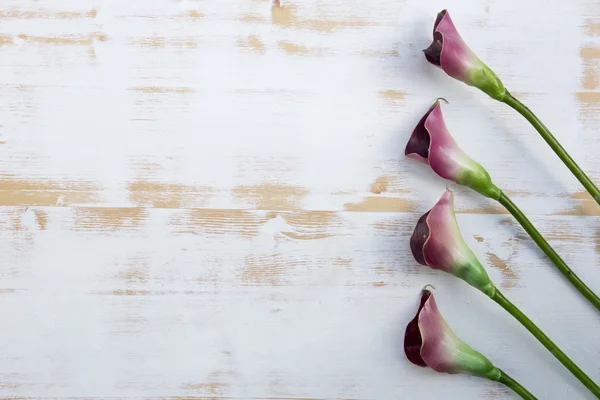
left=501, top=91, right=600, bottom=205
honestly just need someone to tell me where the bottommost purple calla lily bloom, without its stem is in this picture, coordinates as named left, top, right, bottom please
left=404, top=287, right=501, bottom=381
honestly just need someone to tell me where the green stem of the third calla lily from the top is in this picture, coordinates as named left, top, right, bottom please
left=492, top=290, right=600, bottom=399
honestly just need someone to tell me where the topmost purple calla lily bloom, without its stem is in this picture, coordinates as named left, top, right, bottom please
left=423, top=10, right=507, bottom=100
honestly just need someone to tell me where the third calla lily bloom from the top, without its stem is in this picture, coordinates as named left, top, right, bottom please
left=410, top=189, right=496, bottom=297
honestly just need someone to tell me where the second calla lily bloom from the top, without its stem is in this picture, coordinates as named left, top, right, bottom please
left=404, top=99, right=500, bottom=199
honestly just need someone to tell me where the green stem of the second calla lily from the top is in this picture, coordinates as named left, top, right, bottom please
left=497, top=192, right=600, bottom=310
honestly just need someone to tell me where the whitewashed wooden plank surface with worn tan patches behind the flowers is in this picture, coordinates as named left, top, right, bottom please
left=0, top=0, right=600, bottom=400
